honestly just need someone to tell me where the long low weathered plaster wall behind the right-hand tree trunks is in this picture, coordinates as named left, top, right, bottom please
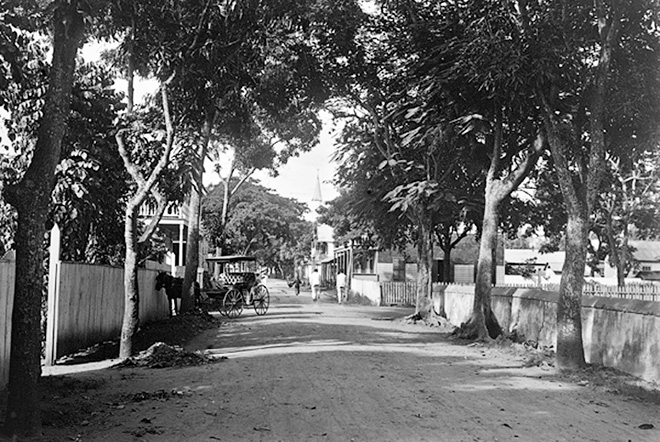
left=434, top=285, right=660, bottom=382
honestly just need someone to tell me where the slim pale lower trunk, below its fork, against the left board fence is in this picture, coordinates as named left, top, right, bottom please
left=119, top=208, right=140, bottom=359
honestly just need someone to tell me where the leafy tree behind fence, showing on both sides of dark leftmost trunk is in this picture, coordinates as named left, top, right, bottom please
left=2, top=54, right=126, bottom=263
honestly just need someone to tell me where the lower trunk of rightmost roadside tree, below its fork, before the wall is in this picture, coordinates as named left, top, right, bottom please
left=557, top=210, right=589, bottom=368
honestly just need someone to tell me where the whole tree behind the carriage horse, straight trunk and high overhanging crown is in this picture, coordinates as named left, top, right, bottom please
left=163, top=1, right=359, bottom=311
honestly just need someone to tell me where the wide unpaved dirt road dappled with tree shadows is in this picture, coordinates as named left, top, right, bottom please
left=5, top=280, right=660, bottom=442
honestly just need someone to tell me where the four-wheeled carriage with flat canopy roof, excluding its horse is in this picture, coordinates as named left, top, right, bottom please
left=202, top=255, right=270, bottom=318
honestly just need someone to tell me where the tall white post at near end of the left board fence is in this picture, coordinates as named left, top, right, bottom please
left=46, top=224, right=62, bottom=365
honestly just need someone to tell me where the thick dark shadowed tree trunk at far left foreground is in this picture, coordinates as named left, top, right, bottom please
left=5, top=1, right=84, bottom=436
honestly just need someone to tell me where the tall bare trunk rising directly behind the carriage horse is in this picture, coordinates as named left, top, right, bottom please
left=181, top=111, right=215, bottom=313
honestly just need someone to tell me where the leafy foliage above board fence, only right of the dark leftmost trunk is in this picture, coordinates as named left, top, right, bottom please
left=50, top=64, right=128, bottom=265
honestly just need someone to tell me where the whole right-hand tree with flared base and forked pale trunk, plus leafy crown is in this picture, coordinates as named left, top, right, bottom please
left=346, top=1, right=543, bottom=328
